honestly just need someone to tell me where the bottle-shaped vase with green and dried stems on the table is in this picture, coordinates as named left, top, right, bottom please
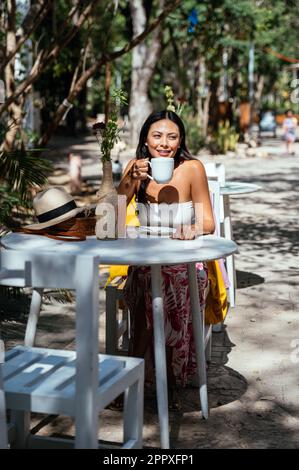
left=92, top=89, right=127, bottom=240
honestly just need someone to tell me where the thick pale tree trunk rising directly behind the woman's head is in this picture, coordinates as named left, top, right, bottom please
left=129, top=0, right=164, bottom=147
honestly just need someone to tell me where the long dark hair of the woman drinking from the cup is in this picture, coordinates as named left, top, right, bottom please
left=136, top=110, right=193, bottom=202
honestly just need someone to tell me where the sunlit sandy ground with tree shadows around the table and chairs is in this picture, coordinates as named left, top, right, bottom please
left=2, top=127, right=299, bottom=449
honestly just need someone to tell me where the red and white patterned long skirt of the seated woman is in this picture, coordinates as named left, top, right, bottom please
left=124, top=263, right=208, bottom=386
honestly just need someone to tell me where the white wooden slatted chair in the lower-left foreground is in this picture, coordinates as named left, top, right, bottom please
left=0, top=250, right=144, bottom=448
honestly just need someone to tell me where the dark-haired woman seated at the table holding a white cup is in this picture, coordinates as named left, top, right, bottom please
left=118, top=111, right=215, bottom=410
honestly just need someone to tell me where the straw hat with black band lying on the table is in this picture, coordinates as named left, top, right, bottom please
left=25, top=186, right=86, bottom=230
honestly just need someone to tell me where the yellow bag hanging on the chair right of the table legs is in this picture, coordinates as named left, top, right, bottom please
left=205, top=261, right=228, bottom=325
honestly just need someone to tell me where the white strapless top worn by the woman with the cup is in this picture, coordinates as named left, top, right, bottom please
left=137, top=201, right=195, bottom=227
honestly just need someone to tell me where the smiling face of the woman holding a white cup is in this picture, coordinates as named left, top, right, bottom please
left=146, top=119, right=180, bottom=158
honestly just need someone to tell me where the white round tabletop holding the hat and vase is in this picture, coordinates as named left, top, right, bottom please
left=1, top=232, right=238, bottom=265
